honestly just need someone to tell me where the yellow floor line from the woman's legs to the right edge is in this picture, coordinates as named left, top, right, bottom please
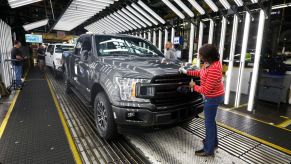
left=202, top=116, right=291, bottom=155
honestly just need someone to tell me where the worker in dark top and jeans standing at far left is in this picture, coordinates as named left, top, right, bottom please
left=11, top=40, right=27, bottom=89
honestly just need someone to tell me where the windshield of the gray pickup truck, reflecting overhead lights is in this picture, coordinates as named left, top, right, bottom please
left=96, top=36, right=163, bottom=57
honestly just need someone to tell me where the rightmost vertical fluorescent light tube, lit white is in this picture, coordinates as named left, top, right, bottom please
left=247, top=9, right=265, bottom=111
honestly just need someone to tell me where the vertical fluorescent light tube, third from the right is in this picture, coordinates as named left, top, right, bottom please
left=224, top=14, right=238, bottom=104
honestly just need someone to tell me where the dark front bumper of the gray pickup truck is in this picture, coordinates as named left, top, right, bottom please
left=112, top=102, right=203, bottom=127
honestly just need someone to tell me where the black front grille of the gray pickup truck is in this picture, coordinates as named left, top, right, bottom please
left=151, top=75, right=202, bottom=110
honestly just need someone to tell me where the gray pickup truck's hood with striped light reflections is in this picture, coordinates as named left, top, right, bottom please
left=101, top=56, right=181, bottom=78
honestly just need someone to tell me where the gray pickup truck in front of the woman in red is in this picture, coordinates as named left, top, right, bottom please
left=63, top=34, right=203, bottom=139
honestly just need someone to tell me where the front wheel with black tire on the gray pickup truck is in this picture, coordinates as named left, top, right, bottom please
left=94, top=92, right=117, bottom=140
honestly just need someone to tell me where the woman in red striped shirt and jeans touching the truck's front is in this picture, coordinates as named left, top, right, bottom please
left=180, top=44, right=224, bottom=156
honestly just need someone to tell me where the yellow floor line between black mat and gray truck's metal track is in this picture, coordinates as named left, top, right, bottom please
left=45, top=76, right=82, bottom=164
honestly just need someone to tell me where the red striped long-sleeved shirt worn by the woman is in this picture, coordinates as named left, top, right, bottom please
left=187, top=61, right=224, bottom=98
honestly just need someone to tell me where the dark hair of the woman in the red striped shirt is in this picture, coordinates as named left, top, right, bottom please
left=199, top=44, right=219, bottom=64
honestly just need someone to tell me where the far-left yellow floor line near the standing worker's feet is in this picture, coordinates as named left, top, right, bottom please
left=0, top=69, right=29, bottom=139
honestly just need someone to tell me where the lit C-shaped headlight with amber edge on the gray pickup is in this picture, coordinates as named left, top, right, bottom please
left=116, top=77, right=151, bottom=102
